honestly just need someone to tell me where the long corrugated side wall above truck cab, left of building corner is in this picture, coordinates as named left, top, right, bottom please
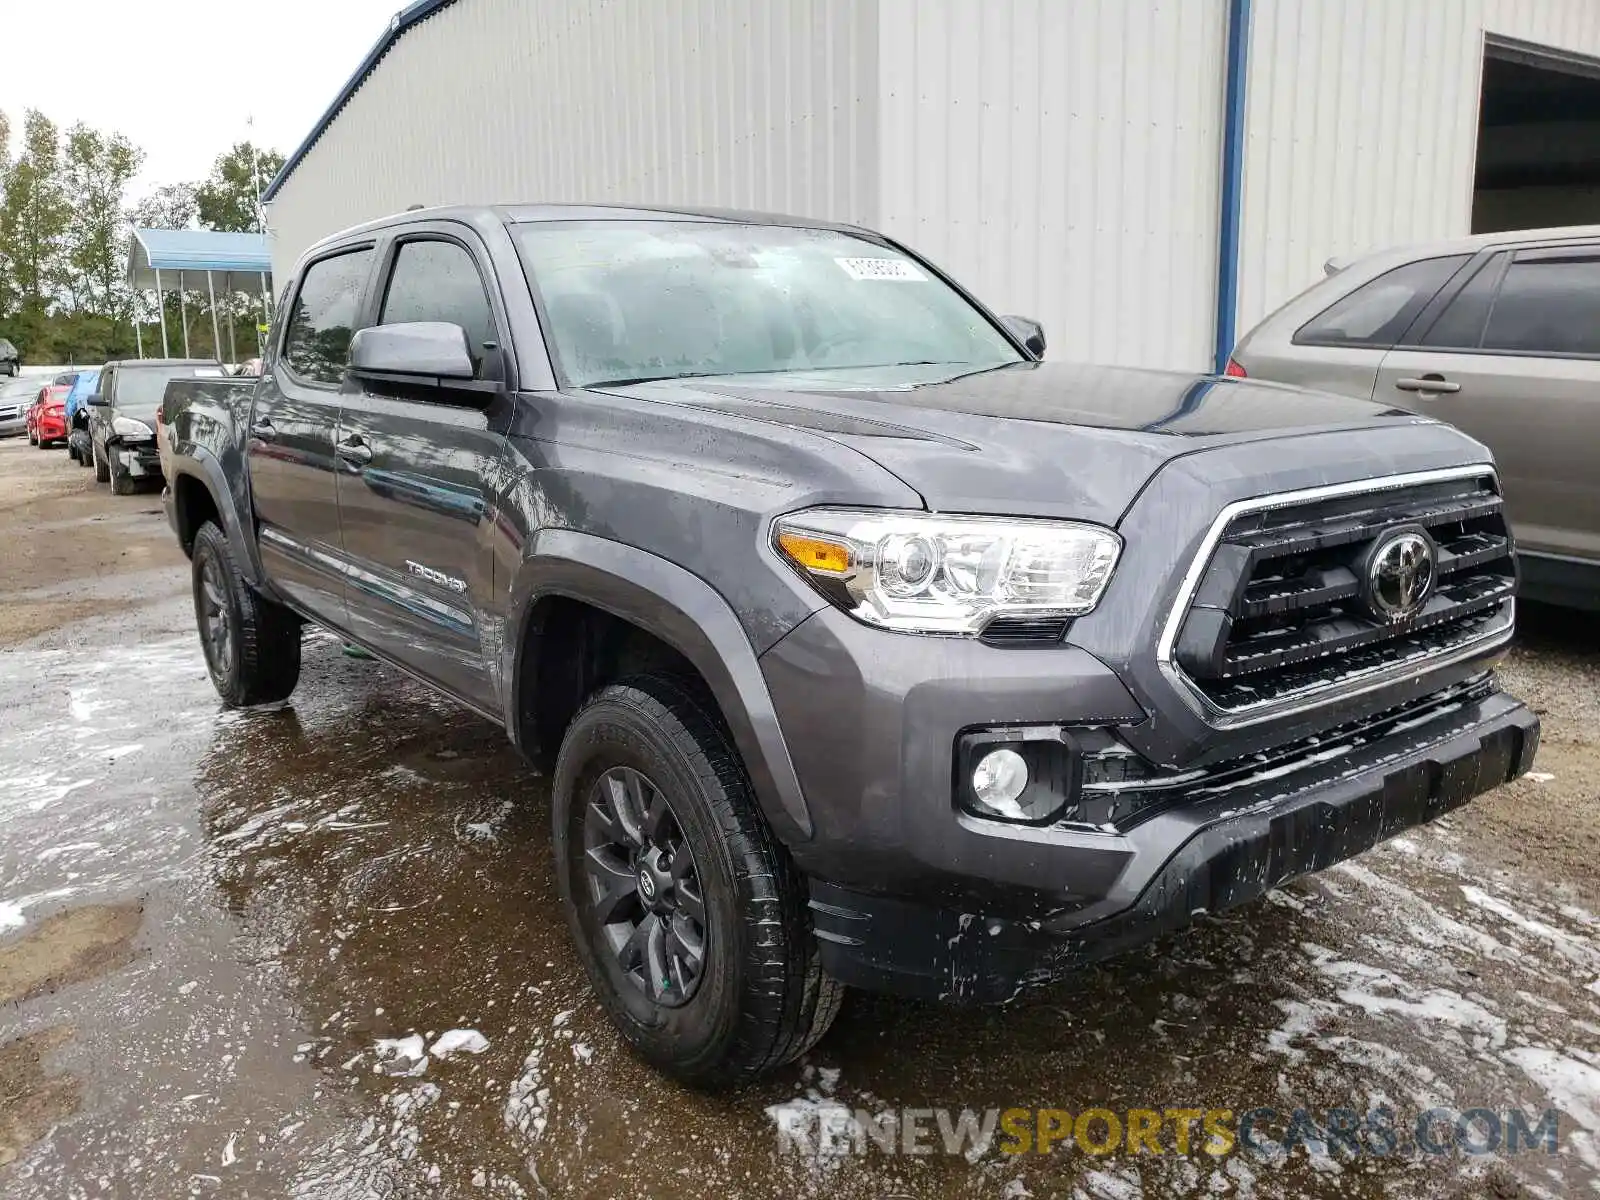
left=269, top=0, right=878, bottom=280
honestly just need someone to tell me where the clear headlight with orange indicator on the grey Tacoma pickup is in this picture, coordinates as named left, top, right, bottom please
left=773, top=509, right=1122, bottom=635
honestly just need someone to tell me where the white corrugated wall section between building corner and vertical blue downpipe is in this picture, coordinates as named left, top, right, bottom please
left=878, top=0, right=1226, bottom=368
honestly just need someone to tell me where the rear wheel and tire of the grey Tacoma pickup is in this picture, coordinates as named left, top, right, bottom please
left=190, top=522, right=301, bottom=709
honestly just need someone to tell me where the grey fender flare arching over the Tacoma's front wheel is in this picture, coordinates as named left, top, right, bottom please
left=502, top=530, right=811, bottom=842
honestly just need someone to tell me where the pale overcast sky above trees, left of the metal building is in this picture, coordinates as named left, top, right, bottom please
left=0, top=0, right=405, bottom=200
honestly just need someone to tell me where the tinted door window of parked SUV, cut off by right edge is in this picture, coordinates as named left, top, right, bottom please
left=1483, top=246, right=1600, bottom=357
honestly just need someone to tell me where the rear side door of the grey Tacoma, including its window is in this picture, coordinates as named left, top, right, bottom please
left=246, top=248, right=373, bottom=627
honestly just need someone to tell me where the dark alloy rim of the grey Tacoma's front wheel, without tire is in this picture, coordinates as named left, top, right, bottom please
left=584, top=766, right=709, bottom=1008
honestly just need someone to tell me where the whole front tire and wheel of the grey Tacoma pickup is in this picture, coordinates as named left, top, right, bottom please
left=550, top=675, right=843, bottom=1088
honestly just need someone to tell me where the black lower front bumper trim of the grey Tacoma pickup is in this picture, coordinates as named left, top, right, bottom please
left=811, top=693, right=1539, bottom=1003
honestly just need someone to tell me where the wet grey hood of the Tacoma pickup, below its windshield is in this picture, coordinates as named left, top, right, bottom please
left=595, top=363, right=1432, bottom=525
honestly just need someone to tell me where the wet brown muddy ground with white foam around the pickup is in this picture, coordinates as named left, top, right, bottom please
left=0, top=440, right=1600, bottom=1200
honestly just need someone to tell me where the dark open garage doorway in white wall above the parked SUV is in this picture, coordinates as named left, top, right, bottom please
left=1472, top=38, right=1600, bottom=234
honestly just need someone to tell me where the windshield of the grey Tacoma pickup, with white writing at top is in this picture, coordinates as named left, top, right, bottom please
left=515, top=221, right=1022, bottom=387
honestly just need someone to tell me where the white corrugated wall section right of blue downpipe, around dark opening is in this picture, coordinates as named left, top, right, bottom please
left=1238, top=0, right=1600, bottom=333
